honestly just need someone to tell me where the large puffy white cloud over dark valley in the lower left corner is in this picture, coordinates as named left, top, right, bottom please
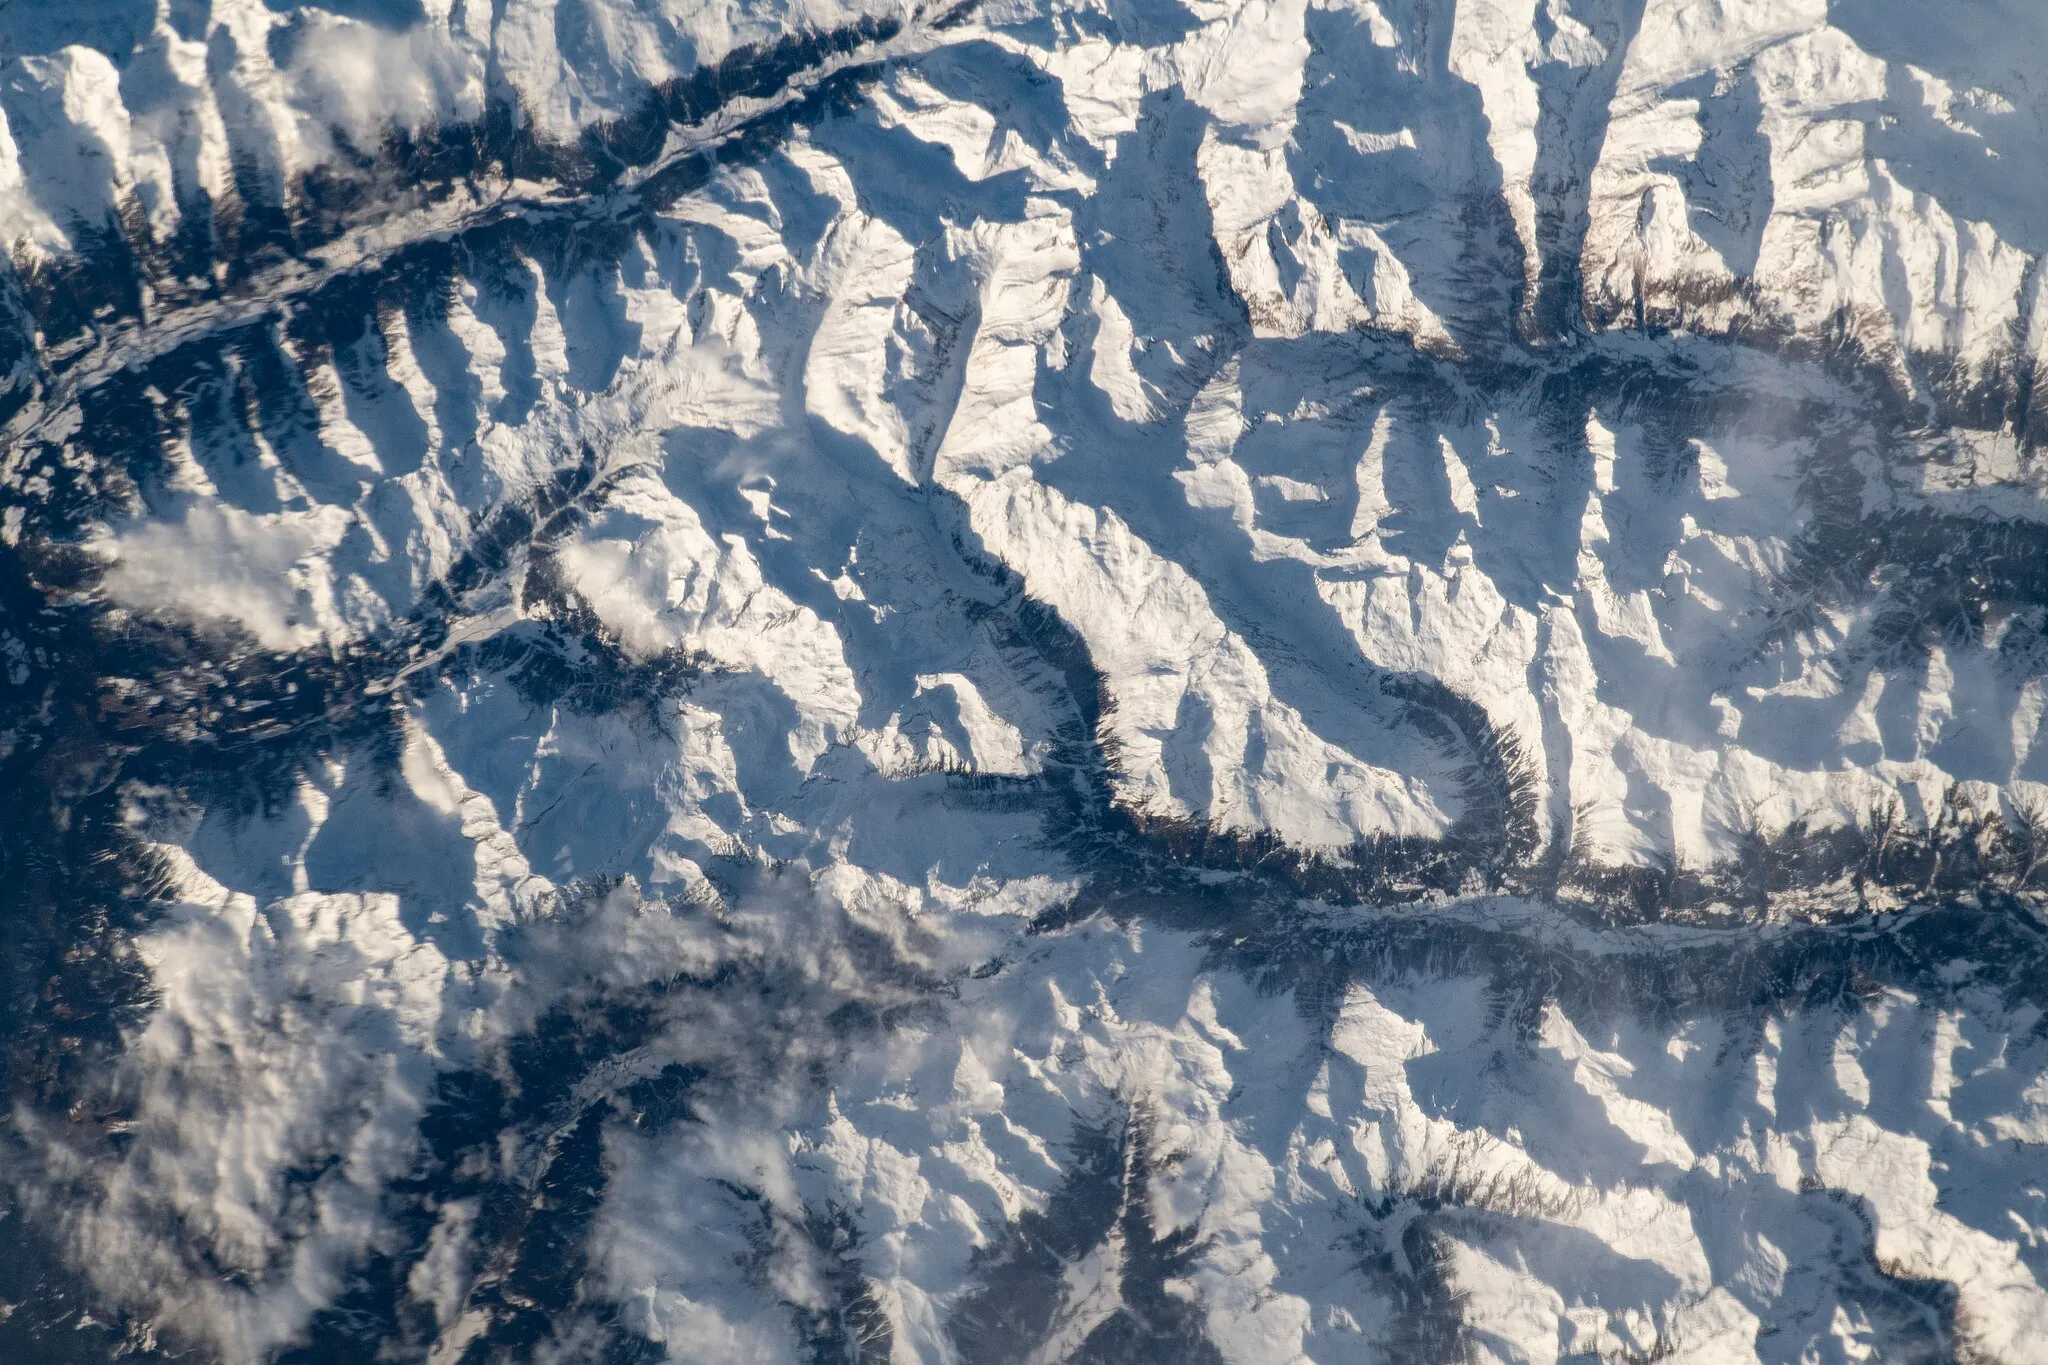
left=25, top=871, right=446, bottom=1365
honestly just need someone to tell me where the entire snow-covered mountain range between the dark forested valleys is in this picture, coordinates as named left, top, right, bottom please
left=12, top=0, right=2048, bottom=1365
